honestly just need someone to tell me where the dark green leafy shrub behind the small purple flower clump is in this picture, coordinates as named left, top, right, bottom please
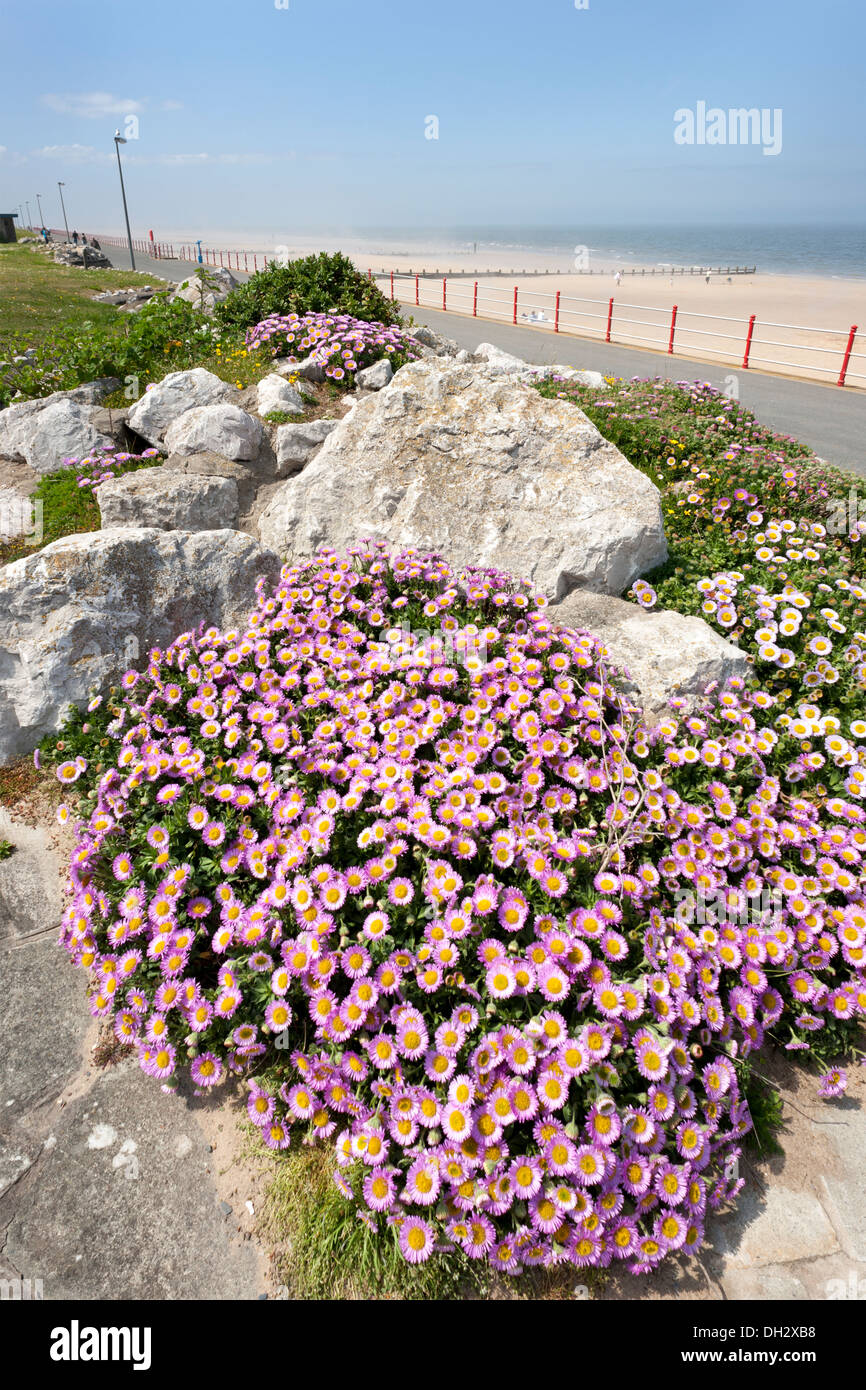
left=214, top=252, right=400, bottom=331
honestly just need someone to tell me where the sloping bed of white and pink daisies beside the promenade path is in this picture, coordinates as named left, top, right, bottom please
left=544, top=381, right=866, bottom=798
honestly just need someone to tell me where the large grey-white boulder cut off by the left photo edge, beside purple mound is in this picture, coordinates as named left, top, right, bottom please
left=0, top=527, right=279, bottom=762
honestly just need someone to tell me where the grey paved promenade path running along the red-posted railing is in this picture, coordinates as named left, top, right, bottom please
left=104, top=246, right=866, bottom=477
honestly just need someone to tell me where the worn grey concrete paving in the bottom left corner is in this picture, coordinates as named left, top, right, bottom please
left=0, top=813, right=267, bottom=1300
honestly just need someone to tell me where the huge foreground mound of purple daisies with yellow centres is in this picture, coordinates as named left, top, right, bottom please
left=44, top=543, right=866, bottom=1273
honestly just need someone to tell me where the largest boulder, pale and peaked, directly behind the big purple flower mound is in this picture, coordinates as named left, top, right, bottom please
left=260, top=359, right=667, bottom=599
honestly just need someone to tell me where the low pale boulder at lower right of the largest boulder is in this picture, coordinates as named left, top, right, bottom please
left=545, top=589, right=749, bottom=719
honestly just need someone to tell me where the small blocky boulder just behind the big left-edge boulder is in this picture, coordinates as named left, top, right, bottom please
left=96, top=467, right=238, bottom=531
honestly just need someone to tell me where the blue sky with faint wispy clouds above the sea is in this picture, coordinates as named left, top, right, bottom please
left=0, top=0, right=866, bottom=236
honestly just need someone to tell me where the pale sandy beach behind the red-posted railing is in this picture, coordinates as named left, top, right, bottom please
left=155, top=228, right=866, bottom=389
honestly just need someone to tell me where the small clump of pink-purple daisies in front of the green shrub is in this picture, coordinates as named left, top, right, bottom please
left=246, top=313, right=420, bottom=382
